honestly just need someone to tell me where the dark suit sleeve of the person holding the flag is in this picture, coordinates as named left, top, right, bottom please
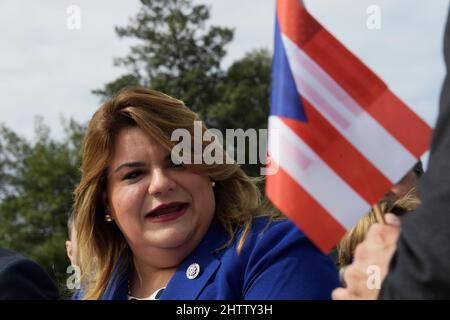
left=380, top=6, right=450, bottom=299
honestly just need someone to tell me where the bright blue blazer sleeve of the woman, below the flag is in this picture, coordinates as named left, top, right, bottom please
left=234, top=217, right=339, bottom=299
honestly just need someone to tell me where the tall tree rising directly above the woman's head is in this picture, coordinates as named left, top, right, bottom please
left=93, top=0, right=233, bottom=121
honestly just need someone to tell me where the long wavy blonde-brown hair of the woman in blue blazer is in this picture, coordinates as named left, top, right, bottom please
left=74, top=88, right=280, bottom=299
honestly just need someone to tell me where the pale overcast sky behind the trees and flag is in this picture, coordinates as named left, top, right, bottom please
left=0, top=0, right=449, bottom=143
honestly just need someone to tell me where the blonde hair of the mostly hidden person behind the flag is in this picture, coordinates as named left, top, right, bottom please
left=337, top=187, right=421, bottom=268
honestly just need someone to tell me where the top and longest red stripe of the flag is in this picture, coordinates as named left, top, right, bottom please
left=277, top=0, right=432, bottom=158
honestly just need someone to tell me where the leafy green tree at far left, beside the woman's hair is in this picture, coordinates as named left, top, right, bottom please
left=0, top=119, right=85, bottom=296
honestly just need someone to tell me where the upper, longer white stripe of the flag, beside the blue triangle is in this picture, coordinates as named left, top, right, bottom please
left=282, top=34, right=417, bottom=183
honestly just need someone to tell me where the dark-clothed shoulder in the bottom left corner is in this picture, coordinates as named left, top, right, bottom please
left=0, top=256, right=59, bottom=300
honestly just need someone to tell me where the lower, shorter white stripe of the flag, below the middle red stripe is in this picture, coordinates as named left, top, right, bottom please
left=268, top=116, right=370, bottom=229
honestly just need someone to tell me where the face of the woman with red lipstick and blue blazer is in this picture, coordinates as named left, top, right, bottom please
left=106, top=128, right=215, bottom=267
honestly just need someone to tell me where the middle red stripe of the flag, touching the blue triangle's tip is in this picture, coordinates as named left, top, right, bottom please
left=282, top=99, right=392, bottom=204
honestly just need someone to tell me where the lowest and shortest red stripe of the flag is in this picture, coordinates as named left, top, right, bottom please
left=266, top=161, right=346, bottom=253
